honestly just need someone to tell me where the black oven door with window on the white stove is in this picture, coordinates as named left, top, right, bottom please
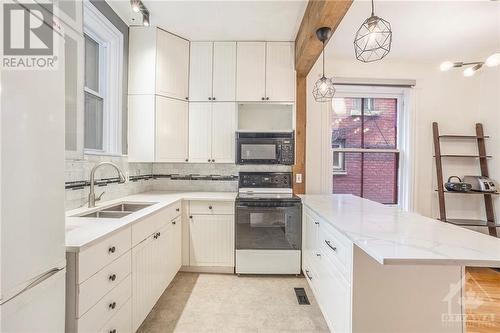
left=236, top=202, right=302, bottom=250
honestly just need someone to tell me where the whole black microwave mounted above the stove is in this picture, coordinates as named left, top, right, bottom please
left=236, top=131, right=295, bottom=165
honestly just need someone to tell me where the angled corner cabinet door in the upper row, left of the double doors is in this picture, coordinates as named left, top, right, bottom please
left=156, top=29, right=189, bottom=100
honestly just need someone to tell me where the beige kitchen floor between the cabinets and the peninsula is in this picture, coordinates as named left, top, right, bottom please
left=138, top=272, right=329, bottom=333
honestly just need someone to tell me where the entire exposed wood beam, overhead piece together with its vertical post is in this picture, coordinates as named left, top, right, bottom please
left=293, top=0, right=352, bottom=193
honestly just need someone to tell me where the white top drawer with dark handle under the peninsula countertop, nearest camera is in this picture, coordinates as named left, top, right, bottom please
left=319, top=220, right=352, bottom=282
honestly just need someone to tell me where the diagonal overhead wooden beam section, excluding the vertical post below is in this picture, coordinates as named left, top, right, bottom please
left=295, top=0, right=352, bottom=76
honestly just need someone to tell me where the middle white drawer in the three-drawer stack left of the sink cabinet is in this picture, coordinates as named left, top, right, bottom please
left=77, top=251, right=132, bottom=317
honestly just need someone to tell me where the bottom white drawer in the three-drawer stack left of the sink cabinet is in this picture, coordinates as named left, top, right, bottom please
left=77, top=275, right=132, bottom=333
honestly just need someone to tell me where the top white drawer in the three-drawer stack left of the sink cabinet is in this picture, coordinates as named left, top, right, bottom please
left=78, top=228, right=131, bottom=283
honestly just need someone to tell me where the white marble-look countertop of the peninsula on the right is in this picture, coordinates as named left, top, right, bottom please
left=299, top=194, right=500, bottom=267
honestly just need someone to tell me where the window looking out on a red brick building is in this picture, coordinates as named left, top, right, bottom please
left=329, top=87, right=406, bottom=208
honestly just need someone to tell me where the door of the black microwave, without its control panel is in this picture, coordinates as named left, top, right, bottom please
left=236, top=139, right=281, bottom=164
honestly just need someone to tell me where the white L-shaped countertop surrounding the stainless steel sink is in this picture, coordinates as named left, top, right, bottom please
left=66, top=191, right=237, bottom=252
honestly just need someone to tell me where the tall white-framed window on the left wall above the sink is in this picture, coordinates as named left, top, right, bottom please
left=84, top=1, right=123, bottom=155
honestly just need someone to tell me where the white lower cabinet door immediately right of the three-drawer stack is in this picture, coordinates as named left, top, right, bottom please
left=132, top=236, right=157, bottom=332
